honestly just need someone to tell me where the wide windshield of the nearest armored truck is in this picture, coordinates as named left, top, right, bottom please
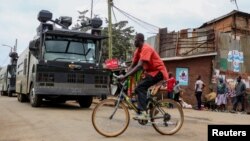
left=44, top=39, right=97, bottom=63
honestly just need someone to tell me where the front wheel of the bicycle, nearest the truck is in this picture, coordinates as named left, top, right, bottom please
left=92, top=99, right=130, bottom=137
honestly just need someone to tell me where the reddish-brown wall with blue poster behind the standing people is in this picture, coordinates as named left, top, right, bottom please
left=165, top=56, right=214, bottom=105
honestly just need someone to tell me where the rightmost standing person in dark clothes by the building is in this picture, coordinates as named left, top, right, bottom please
left=231, top=76, right=246, bottom=113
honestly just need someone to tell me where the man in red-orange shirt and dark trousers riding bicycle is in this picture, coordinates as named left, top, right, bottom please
left=118, top=33, right=168, bottom=120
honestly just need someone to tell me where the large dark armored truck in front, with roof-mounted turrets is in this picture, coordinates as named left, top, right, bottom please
left=16, top=10, right=110, bottom=108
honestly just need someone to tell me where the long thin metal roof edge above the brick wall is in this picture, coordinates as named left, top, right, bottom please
left=161, top=52, right=217, bottom=61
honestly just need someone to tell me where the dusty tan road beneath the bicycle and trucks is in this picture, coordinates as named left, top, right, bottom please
left=0, top=96, right=250, bottom=141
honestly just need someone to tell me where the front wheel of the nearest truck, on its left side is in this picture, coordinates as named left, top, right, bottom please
left=29, top=85, right=42, bottom=107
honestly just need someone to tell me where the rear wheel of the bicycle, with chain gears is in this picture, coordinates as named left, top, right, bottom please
left=151, top=99, right=184, bottom=135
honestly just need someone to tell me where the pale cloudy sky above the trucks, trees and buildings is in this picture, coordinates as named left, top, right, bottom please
left=0, top=0, right=250, bottom=66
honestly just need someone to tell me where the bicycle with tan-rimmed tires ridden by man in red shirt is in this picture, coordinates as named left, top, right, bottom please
left=92, top=75, right=184, bottom=137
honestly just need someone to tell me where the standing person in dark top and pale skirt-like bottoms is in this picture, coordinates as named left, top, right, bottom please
left=215, top=78, right=227, bottom=111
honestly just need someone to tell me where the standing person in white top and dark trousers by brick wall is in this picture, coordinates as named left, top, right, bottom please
left=195, top=75, right=205, bottom=110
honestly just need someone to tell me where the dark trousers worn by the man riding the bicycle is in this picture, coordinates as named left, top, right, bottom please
left=135, top=72, right=163, bottom=111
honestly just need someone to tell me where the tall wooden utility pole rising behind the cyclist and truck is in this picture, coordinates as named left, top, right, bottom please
left=108, top=0, right=113, bottom=59
